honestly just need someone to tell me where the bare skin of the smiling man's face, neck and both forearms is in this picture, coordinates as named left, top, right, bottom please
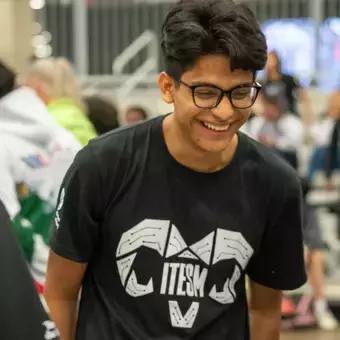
left=45, top=55, right=281, bottom=340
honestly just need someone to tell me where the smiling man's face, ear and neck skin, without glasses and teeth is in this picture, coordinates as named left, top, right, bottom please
left=158, top=55, right=253, bottom=172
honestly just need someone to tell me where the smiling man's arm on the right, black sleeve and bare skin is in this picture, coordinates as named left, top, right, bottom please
left=247, top=174, right=306, bottom=340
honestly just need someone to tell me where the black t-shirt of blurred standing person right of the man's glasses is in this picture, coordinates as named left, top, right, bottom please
left=262, top=74, right=300, bottom=114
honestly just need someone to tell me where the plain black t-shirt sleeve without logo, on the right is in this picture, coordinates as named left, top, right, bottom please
left=247, top=176, right=307, bottom=290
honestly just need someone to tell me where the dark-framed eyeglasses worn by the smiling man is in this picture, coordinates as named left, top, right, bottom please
left=179, top=80, right=262, bottom=109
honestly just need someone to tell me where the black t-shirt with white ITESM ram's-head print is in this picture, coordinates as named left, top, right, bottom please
left=51, top=117, right=306, bottom=340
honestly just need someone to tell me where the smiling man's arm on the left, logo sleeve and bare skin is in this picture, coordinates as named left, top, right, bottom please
left=44, top=145, right=102, bottom=340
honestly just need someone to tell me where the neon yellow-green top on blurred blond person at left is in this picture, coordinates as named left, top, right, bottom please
left=47, top=98, right=97, bottom=146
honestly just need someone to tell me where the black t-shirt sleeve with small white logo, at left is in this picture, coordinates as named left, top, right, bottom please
left=50, top=145, right=102, bottom=263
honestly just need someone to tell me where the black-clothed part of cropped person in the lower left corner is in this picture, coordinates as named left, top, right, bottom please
left=0, top=201, right=59, bottom=340
